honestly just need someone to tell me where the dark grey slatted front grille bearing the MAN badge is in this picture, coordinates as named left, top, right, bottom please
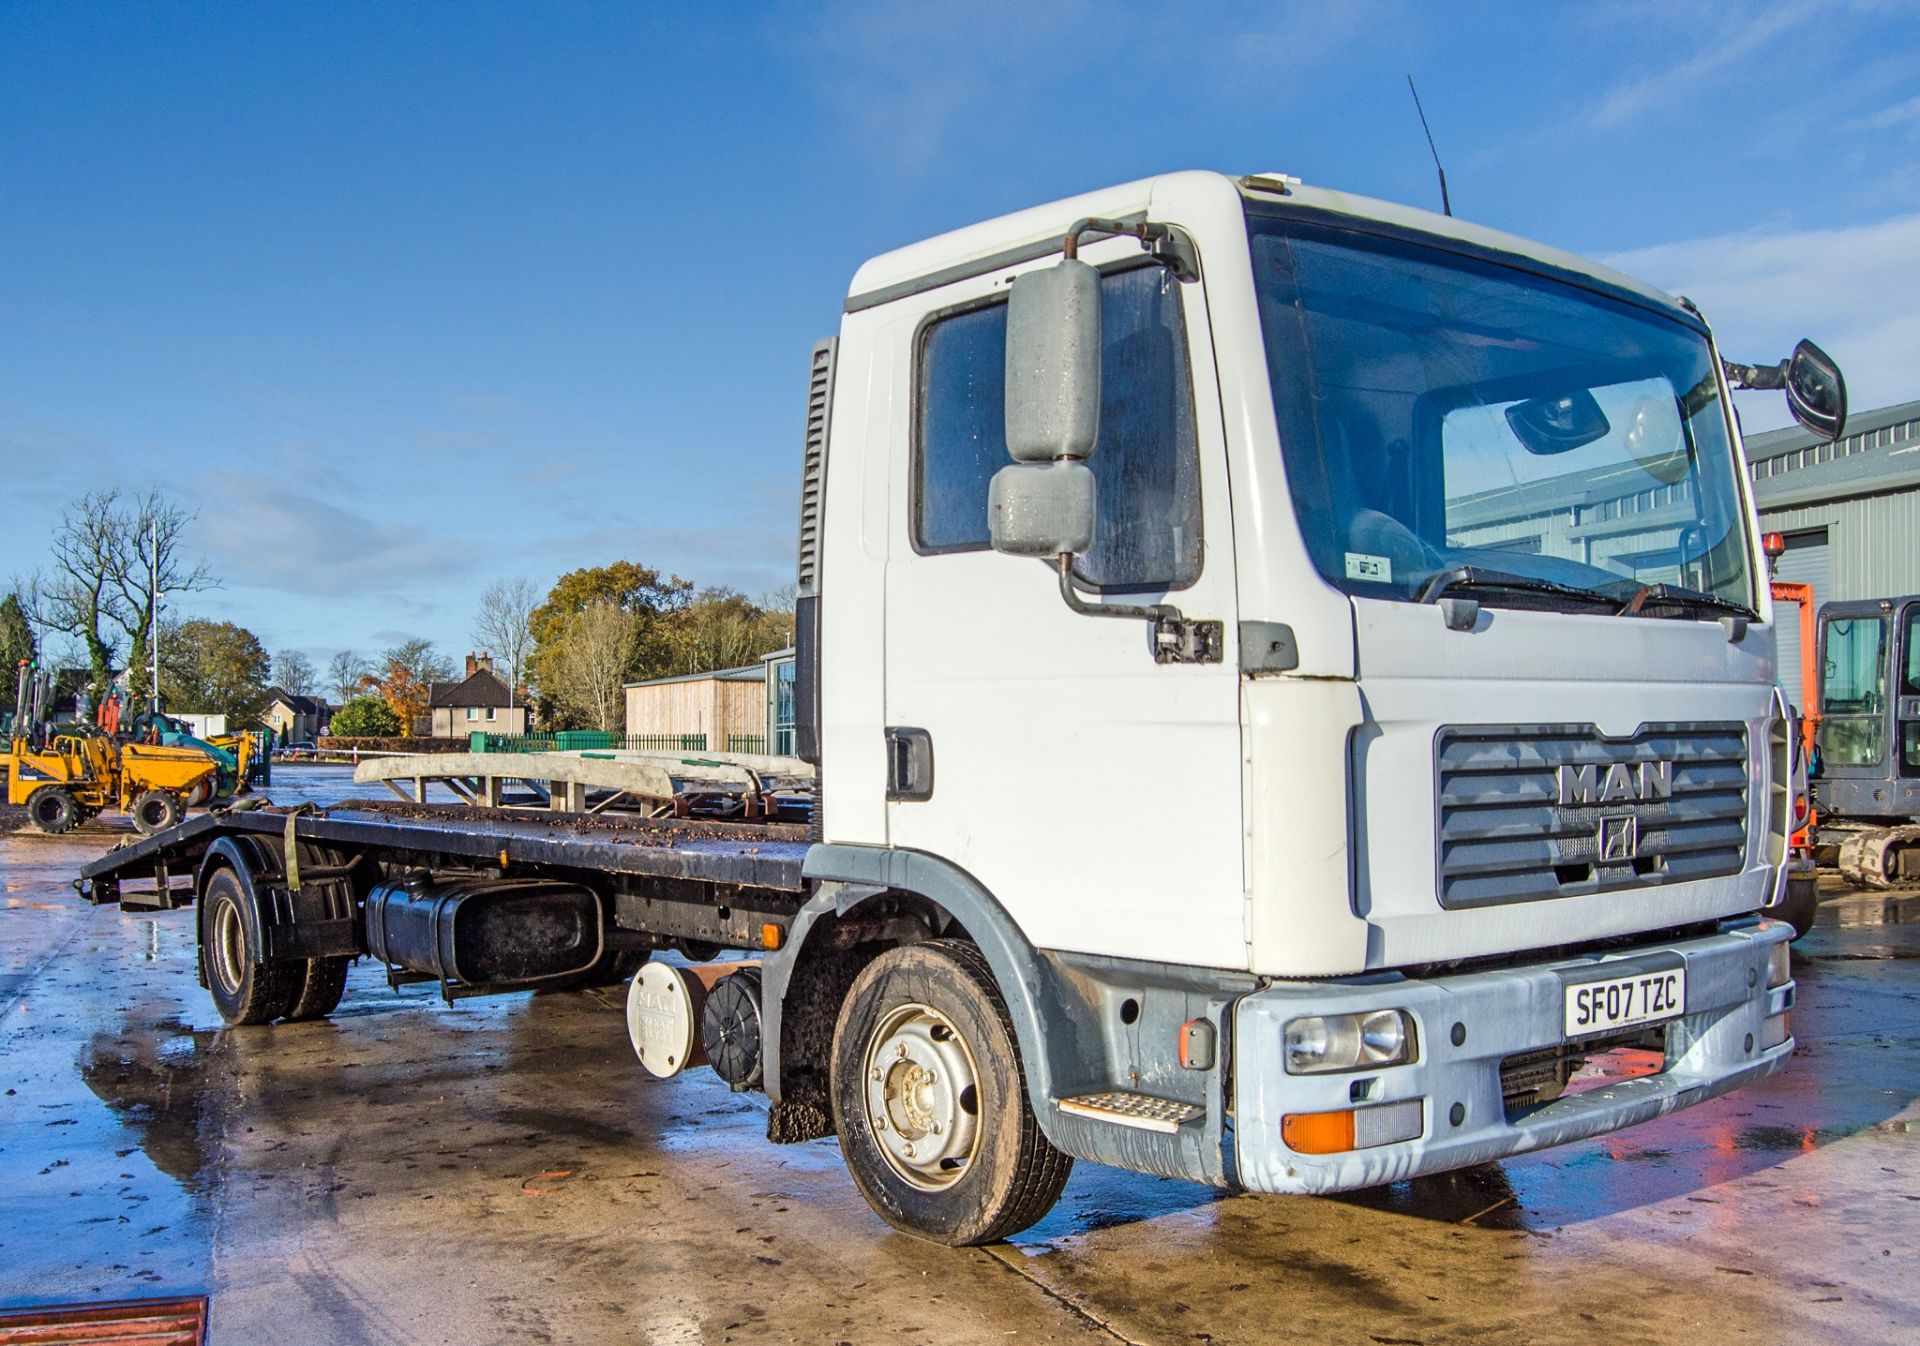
left=1434, top=722, right=1747, bottom=908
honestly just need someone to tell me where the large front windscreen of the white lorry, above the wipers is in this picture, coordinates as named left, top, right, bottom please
left=1248, top=213, right=1753, bottom=613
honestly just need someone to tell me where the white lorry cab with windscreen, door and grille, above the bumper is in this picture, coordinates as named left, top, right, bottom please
left=803, top=173, right=1786, bottom=975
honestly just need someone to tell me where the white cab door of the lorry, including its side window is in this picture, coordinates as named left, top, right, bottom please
left=885, top=240, right=1246, bottom=968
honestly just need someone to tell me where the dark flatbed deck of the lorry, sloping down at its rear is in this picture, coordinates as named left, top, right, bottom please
left=81, top=801, right=806, bottom=901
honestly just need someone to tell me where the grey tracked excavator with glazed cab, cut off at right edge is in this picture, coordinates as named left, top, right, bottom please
left=1814, top=595, right=1920, bottom=887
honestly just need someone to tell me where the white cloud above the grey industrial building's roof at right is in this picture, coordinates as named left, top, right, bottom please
left=1607, top=213, right=1920, bottom=430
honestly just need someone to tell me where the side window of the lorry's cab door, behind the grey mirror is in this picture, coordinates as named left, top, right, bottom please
left=912, top=265, right=1200, bottom=589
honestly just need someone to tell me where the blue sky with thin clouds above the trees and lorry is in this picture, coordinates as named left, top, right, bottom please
left=0, top=0, right=1920, bottom=662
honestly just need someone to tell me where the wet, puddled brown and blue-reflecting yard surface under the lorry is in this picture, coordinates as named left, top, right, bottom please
left=0, top=768, right=1920, bottom=1346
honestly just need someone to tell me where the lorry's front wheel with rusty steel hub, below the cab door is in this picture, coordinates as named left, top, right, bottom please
left=831, top=939, right=1073, bottom=1246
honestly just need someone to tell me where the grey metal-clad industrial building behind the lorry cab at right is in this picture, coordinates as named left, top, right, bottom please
left=1747, top=401, right=1920, bottom=701
